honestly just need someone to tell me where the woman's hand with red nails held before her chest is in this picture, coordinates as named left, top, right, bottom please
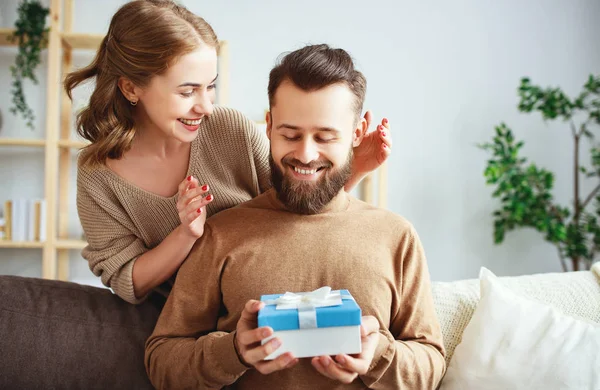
left=177, top=176, right=213, bottom=238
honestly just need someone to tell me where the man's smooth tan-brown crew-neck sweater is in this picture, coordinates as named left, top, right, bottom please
left=146, top=190, right=445, bottom=390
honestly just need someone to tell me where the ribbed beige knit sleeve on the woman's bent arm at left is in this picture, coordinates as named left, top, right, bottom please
left=77, top=168, right=148, bottom=304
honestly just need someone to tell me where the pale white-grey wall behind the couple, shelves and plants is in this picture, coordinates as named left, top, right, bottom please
left=0, top=0, right=600, bottom=280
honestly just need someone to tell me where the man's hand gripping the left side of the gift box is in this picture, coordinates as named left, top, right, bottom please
left=234, top=300, right=298, bottom=374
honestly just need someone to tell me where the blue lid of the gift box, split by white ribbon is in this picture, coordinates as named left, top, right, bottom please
left=258, top=290, right=361, bottom=331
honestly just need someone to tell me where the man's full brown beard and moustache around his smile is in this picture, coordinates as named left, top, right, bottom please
left=269, top=148, right=353, bottom=215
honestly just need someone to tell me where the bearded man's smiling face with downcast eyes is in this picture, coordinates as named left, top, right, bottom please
left=267, top=81, right=362, bottom=214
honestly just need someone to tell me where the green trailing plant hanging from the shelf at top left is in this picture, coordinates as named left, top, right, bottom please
left=9, top=0, right=50, bottom=129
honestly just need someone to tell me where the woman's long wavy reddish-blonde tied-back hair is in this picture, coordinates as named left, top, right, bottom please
left=64, top=0, right=219, bottom=165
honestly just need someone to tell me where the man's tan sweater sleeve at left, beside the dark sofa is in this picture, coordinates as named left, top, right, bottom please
left=145, top=224, right=248, bottom=389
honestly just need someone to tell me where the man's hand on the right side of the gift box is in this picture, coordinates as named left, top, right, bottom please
left=312, top=316, right=379, bottom=384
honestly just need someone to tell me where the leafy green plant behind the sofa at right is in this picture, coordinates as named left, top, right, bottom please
left=479, top=75, right=600, bottom=271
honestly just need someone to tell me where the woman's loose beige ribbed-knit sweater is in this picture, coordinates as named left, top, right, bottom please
left=77, top=107, right=270, bottom=303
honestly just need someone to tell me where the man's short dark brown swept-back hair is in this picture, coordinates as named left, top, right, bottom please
left=268, top=44, right=367, bottom=118
